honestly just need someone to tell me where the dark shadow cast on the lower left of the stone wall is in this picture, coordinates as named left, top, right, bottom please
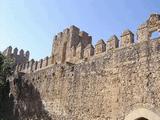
left=11, top=74, right=51, bottom=120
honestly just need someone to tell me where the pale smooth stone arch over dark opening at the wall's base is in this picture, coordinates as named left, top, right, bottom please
left=125, top=108, right=160, bottom=120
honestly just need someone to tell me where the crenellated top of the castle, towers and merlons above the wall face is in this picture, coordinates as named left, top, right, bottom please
left=4, top=14, right=160, bottom=72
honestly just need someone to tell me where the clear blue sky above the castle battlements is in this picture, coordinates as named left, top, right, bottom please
left=0, top=0, right=160, bottom=59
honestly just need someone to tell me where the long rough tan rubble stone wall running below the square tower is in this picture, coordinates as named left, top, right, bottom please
left=10, top=15, right=160, bottom=120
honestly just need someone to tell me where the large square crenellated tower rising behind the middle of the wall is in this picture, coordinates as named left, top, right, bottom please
left=51, top=26, right=92, bottom=64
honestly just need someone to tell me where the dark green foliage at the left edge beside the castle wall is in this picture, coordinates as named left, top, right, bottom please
left=0, top=53, right=13, bottom=120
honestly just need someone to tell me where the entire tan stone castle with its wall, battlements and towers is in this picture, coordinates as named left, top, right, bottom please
left=3, top=14, right=160, bottom=120
